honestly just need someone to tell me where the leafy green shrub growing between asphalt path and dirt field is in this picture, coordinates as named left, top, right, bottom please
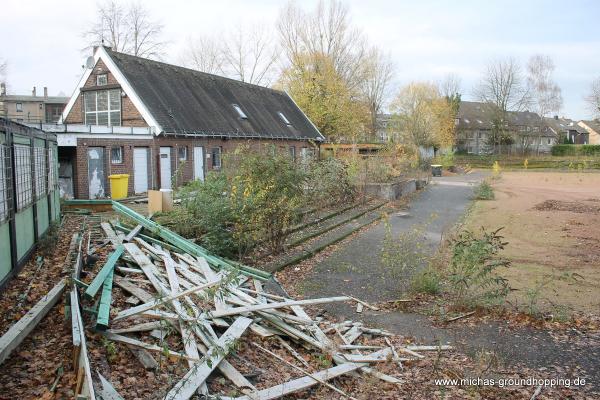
left=448, top=228, right=510, bottom=307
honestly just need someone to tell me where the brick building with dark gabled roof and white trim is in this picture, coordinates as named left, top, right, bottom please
left=58, top=47, right=324, bottom=198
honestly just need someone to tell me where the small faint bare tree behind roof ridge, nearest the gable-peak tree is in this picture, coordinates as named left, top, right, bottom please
left=180, top=36, right=223, bottom=74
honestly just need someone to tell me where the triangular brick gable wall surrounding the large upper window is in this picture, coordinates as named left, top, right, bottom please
left=65, top=60, right=148, bottom=127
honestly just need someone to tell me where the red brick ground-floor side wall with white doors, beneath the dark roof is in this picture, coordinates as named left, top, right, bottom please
left=75, top=136, right=311, bottom=199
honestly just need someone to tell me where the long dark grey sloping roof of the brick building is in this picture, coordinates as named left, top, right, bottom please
left=106, top=50, right=324, bottom=141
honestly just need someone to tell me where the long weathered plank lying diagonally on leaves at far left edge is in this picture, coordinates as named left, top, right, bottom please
left=0, top=279, right=66, bottom=364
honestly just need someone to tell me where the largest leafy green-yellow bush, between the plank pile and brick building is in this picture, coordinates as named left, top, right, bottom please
left=175, top=148, right=305, bottom=259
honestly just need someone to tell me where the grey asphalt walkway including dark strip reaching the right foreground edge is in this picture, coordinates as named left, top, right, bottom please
left=298, top=172, right=600, bottom=393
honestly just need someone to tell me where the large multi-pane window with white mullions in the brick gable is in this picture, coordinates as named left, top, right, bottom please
left=83, top=89, right=121, bottom=126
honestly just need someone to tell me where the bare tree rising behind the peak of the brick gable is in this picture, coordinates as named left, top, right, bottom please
left=84, top=0, right=165, bottom=58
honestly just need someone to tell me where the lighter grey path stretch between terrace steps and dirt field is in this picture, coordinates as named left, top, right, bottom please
left=301, top=172, right=484, bottom=302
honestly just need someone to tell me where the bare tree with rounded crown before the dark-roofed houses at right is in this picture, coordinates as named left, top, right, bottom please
left=475, top=58, right=530, bottom=151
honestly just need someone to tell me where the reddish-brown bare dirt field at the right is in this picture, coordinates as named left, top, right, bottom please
left=467, top=172, right=600, bottom=314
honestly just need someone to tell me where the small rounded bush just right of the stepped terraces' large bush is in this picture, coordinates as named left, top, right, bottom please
left=306, top=158, right=356, bottom=208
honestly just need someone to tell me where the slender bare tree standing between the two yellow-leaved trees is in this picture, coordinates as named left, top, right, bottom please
left=361, top=47, right=394, bottom=135
